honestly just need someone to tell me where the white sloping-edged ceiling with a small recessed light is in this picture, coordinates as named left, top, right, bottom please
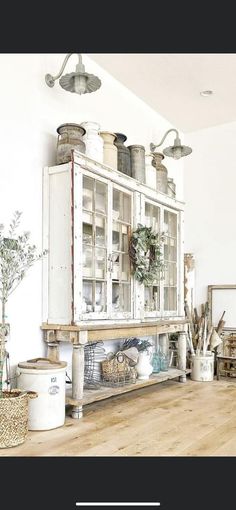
left=88, top=53, right=236, bottom=133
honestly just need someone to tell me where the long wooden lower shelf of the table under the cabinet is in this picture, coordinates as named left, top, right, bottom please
left=66, top=368, right=191, bottom=406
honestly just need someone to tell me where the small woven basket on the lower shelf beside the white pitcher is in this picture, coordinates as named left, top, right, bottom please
left=101, top=352, right=137, bottom=387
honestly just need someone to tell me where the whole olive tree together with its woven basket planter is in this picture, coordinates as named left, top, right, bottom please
left=0, top=211, right=46, bottom=448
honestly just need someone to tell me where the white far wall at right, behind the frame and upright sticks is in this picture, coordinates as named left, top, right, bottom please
left=184, top=122, right=236, bottom=311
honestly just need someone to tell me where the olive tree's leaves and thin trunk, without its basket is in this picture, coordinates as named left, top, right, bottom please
left=0, top=211, right=47, bottom=398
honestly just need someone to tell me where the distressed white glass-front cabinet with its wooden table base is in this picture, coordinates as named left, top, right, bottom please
left=42, top=151, right=186, bottom=417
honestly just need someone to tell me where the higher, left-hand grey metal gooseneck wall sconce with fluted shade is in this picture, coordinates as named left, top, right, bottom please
left=45, top=53, right=102, bottom=94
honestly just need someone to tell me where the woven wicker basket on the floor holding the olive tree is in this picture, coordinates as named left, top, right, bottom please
left=0, top=390, right=37, bottom=448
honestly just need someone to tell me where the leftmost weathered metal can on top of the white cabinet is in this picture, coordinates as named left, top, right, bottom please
left=57, top=124, right=86, bottom=165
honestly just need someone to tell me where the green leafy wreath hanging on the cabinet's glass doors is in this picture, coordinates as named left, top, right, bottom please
left=129, top=224, right=165, bottom=285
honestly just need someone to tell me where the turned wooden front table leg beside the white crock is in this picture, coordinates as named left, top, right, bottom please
left=72, top=331, right=87, bottom=419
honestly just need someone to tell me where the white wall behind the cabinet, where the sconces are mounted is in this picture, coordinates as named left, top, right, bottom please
left=0, top=54, right=183, bottom=378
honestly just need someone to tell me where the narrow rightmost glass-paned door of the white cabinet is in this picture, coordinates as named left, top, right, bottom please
left=163, top=210, right=178, bottom=312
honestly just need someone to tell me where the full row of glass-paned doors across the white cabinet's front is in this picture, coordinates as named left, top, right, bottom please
left=74, top=168, right=181, bottom=320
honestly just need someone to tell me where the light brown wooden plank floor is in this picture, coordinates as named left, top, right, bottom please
left=0, top=379, right=236, bottom=456
